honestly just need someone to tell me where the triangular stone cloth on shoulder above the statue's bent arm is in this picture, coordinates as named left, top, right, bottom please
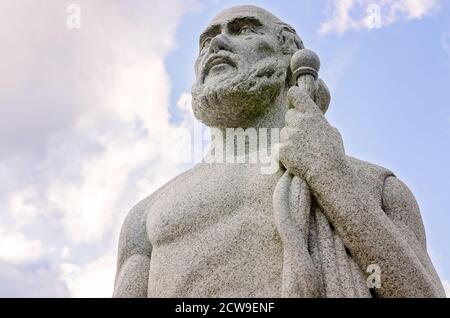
left=347, top=156, right=395, bottom=200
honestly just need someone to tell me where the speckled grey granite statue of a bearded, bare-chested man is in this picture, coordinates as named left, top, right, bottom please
left=114, top=6, right=445, bottom=297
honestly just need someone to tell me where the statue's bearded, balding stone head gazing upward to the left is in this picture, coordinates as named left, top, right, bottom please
left=192, top=6, right=303, bottom=127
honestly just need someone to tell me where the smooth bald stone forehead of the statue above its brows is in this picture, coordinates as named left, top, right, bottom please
left=209, top=6, right=281, bottom=25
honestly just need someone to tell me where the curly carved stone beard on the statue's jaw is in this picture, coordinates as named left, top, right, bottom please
left=192, top=57, right=289, bottom=128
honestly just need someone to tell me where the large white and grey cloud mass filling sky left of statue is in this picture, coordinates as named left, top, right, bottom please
left=0, top=0, right=199, bottom=297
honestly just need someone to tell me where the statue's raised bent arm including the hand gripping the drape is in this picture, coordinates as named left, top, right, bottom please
left=279, top=85, right=444, bottom=297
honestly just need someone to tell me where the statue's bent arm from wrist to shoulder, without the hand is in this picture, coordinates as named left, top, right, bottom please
left=308, top=165, right=445, bottom=297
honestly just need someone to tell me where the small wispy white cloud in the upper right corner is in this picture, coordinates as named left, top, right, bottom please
left=319, top=0, right=440, bottom=35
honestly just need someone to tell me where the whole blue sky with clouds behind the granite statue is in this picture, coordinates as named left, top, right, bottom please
left=0, top=0, right=450, bottom=297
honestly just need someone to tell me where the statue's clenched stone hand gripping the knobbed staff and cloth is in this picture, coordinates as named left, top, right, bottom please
left=279, top=86, right=346, bottom=183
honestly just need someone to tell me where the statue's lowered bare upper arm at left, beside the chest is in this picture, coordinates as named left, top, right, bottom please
left=113, top=199, right=152, bottom=298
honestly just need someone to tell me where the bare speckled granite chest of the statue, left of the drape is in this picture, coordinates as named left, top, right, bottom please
left=147, top=165, right=279, bottom=247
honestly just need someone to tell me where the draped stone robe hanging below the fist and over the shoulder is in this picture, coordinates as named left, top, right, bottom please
left=274, top=157, right=394, bottom=298
